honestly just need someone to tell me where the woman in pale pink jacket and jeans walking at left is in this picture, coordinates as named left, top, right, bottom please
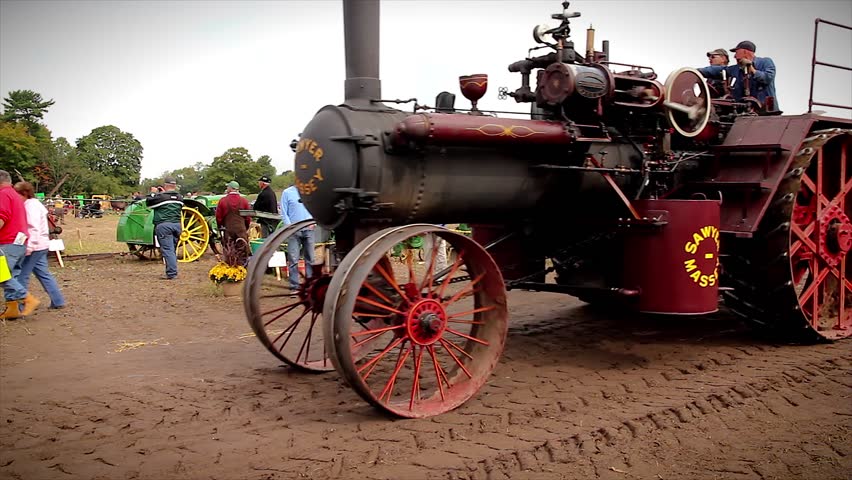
left=15, top=182, right=65, bottom=308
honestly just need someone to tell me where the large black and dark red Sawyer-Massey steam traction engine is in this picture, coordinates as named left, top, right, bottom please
left=245, top=0, right=852, bottom=417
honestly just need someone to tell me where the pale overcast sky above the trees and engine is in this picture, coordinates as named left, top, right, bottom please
left=0, top=0, right=852, bottom=178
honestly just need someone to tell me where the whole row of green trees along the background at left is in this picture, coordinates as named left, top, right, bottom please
left=0, top=90, right=294, bottom=197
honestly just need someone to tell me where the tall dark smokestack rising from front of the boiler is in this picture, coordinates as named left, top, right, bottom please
left=343, top=0, right=382, bottom=103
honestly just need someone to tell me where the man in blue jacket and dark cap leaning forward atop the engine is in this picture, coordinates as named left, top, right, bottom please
left=698, top=40, right=778, bottom=110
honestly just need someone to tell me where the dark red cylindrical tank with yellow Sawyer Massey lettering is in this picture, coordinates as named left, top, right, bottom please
left=624, top=200, right=720, bottom=315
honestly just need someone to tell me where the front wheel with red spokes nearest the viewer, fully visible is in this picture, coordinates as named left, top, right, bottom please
left=324, top=225, right=508, bottom=418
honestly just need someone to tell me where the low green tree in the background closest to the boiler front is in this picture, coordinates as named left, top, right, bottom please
left=203, top=147, right=275, bottom=195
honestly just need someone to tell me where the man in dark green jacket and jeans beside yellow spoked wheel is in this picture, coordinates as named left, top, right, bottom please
left=145, top=177, right=183, bottom=280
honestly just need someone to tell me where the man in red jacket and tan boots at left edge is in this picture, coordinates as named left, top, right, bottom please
left=0, top=170, right=40, bottom=319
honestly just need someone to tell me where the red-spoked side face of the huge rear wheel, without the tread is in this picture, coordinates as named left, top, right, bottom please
left=790, top=134, right=852, bottom=340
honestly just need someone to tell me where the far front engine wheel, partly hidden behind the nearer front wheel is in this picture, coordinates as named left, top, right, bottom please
left=243, top=220, right=334, bottom=372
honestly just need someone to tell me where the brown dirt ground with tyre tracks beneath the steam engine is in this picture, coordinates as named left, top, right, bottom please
left=0, top=217, right=852, bottom=480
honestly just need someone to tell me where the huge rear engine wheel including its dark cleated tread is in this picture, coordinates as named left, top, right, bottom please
left=725, top=129, right=852, bottom=343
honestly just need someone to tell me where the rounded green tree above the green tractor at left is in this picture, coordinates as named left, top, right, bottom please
left=77, top=125, right=142, bottom=189
